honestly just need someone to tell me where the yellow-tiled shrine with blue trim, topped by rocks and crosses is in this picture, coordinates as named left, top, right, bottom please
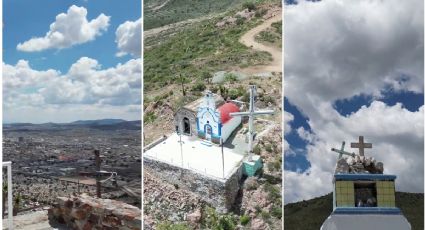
left=321, top=136, right=411, bottom=230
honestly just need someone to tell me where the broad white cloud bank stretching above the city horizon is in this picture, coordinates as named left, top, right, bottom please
left=3, top=57, right=141, bottom=122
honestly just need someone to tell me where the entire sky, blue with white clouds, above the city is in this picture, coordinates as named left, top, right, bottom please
left=3, top=0, right=141, bottom=123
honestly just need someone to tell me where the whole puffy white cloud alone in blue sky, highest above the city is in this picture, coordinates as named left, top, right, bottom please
left=16, top=5, right=110, bottom=52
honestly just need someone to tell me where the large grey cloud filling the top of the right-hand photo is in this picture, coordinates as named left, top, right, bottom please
left=285, top=0, right=424, bottom=112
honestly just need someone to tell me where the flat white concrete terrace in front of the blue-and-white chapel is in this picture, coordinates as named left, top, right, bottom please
left=144, top=133, right=245, bottom=180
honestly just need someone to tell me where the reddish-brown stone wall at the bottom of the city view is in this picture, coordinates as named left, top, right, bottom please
left=48, top=194, right=142, bottom=230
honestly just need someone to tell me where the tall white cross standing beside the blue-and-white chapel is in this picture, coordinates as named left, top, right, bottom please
left=230, top=85, right=274, bottom=160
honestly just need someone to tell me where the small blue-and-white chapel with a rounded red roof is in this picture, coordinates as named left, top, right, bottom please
left=174, top=91, right=242, bottom=144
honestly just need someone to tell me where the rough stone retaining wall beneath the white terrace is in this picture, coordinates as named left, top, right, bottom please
left=143, top=157, right=242, bottom=213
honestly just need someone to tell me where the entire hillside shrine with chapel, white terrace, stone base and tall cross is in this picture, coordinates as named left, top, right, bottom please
left=143, top=85, right=273, bottom=212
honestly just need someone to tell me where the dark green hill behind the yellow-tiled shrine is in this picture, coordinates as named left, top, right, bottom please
left=284, top=192, right=424, bottom=230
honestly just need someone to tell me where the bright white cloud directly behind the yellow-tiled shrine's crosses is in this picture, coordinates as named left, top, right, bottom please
left=285, top=101, right=424, bottom=202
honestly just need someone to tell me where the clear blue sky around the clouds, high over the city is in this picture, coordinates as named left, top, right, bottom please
left=3, top=0, right=141, bottom=73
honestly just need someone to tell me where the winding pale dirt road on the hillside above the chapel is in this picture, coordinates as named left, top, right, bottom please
left=239, top=14, right=282, bottom=74
